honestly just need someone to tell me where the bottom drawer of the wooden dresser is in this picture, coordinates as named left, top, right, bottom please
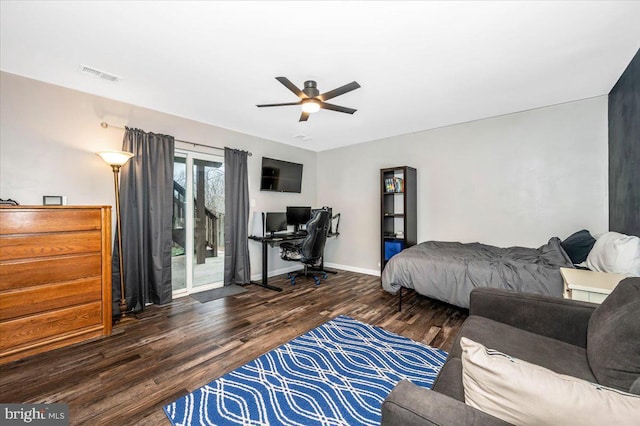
left=0, top=302, right=102, bottom=353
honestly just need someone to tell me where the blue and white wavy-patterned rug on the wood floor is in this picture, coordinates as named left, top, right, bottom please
left=164, top=316, right=447, bottom=426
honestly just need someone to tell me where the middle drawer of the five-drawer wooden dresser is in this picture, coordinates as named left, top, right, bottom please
left=0, top=253, right=102, bottom=291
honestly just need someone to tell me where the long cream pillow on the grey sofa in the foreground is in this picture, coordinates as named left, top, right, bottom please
left=460, top=337, right=640, bottom=425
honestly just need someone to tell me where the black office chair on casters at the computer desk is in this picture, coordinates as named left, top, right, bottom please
left=280, top=210, right=331, bottom=285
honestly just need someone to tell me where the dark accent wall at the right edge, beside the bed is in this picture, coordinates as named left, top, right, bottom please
left=609, top=50, right=640, bottom=236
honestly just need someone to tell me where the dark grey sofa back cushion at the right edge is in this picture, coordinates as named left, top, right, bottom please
left=587, top=278, right=640, bottom=390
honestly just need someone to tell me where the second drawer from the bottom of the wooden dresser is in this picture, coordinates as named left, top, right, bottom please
left=0, top=276, right=102, bottom=320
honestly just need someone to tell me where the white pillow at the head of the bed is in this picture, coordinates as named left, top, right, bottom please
left=587, top=232, right=640, bottom=277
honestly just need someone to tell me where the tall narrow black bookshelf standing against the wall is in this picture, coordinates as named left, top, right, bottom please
left=380, top=166, right=418, bottom=270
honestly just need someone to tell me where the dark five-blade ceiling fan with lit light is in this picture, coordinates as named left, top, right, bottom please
left=256, top=77, right=360, bottom=121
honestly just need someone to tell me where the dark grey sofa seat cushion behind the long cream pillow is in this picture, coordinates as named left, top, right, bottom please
left=449, top=315, right=596, bottom=382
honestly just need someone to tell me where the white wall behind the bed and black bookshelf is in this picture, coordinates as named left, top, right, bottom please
left=318, top=96, right=608, bottom=273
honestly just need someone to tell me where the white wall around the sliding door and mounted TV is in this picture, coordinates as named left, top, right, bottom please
left=0, top=72, right=316, bottom=278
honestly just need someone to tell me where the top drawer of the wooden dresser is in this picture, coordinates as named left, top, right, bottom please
left=0, top=208, right=101, bottom=235
